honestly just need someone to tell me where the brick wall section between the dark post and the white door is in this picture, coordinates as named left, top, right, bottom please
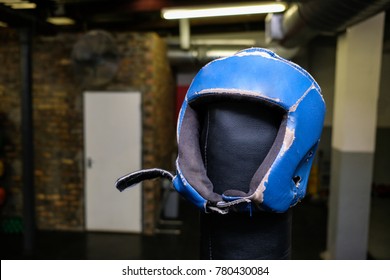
left=33, top=35, right=84, bottom=230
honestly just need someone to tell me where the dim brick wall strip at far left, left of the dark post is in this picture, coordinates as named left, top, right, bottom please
left=0, top=28, right=23, bottom=219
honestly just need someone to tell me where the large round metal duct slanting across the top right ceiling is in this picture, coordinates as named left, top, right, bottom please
left=266, top=0, right=390, bottom=48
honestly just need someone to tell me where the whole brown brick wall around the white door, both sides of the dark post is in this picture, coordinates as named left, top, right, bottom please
left=0, top=30, right=175, bottom=234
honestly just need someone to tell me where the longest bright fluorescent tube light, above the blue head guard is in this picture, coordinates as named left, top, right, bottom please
left=161, top=2, right=286, bottom=19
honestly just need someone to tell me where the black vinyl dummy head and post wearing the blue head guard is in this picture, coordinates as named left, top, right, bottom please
left=200, top=100, right=292, bottom=259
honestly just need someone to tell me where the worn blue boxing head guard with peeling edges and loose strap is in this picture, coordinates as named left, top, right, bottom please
left=117, top=48, right=325, bottom=213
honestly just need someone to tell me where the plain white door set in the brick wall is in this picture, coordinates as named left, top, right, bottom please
left=84, top=92, right=142, bottom=232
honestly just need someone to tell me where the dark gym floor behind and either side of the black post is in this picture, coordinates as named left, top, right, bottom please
left=0, top=196, right=390, bottom=260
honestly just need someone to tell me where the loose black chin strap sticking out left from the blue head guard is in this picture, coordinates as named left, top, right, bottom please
left=115, top=168, right=174, bottom=192
